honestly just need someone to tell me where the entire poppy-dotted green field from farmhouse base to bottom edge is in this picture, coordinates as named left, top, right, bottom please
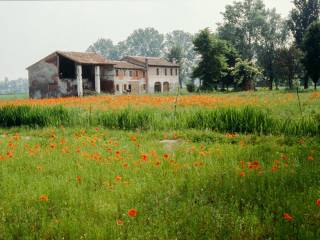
left=0, top=92, right=320, bottom=239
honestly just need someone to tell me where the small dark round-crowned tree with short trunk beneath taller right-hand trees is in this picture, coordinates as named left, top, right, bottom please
left=275, top=45, right=303, bottom=89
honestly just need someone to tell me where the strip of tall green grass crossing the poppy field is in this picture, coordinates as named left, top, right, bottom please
left=0, top=106, right=320, bottom=136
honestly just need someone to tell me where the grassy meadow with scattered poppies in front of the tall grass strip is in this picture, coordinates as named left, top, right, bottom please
left=0, top=128, right=320, bottom=239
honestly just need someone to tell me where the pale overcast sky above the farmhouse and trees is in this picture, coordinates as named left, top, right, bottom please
left=0, top=0, right=292, bottom=81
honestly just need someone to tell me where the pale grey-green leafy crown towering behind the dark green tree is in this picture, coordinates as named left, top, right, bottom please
left=218, top=0, right=267, bottom=60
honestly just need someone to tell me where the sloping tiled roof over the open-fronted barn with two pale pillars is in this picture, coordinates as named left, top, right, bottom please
left=57, top=51, right=113, bottom=64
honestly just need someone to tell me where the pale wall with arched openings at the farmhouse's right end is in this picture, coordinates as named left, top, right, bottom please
left=148, top=67, right=179, bottom=93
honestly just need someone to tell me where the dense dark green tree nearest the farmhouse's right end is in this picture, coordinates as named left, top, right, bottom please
left=192, top=28, right=227, bottom=90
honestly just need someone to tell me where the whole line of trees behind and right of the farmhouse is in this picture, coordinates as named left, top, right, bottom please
left=87, top=0, right=320, bottom=91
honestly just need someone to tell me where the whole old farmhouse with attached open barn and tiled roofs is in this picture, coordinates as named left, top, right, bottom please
left=27, top=51, right=179, bottom=98
